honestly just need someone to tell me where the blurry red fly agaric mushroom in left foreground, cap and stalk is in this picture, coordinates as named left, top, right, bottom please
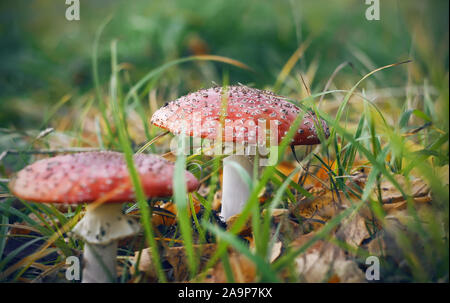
left=9, top=151, right=198, bottom=283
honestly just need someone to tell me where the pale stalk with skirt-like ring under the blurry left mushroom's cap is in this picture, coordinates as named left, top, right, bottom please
left=73, top=203, right=140, bottom=283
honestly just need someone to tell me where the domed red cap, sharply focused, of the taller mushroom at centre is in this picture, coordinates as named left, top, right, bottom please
left=151, top=85, right=329, bottom=145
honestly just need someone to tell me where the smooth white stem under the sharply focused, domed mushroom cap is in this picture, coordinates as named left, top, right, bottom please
left=220, top=155, right=253, bottom=221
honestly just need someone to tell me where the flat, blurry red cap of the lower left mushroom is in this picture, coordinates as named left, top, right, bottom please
left=9, top=151, right=199, bottom=204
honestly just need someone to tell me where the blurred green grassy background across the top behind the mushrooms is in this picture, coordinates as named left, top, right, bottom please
left=0, top=0, right=449, bottom=129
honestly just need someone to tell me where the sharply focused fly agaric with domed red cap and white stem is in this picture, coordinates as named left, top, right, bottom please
left=151, top=85, right=329, bottom=221
